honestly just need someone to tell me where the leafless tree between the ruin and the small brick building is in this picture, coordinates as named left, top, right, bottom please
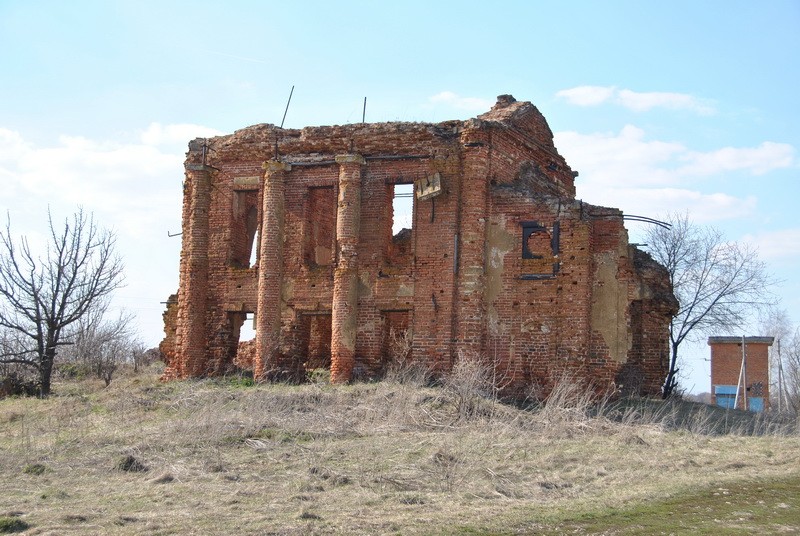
left=647, top=214, right=776, bottom=398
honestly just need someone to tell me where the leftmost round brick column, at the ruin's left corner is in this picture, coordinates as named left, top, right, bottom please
left=175, top=164, right=212, bottom=378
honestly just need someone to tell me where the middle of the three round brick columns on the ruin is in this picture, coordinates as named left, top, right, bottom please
left=253, top=160, right=292, bottom=381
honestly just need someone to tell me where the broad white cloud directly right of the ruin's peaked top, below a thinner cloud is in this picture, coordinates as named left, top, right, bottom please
left=555, top=125, right=796, bottom=222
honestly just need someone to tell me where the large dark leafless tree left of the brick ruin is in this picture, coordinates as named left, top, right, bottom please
left=0, top=209, right=122, bottom=396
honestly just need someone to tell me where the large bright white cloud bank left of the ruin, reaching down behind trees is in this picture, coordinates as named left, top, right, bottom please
left=0, top=123, right=225, bottom=344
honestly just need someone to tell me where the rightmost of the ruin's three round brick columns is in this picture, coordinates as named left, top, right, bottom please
left=331, top=154, right=364, bottom=383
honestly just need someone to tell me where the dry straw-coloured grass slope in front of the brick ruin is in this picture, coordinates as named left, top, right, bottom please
left=0, top=366, right=800, bottom=534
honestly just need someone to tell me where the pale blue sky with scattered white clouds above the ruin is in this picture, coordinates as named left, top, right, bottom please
left=0, top=0, right=800, bottom=391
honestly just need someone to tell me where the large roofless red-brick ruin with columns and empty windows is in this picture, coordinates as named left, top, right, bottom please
left=161, top=95, right=677, bottom=395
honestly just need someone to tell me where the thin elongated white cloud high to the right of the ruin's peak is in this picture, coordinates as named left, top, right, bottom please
left=556, top=86, right=715, bottom=115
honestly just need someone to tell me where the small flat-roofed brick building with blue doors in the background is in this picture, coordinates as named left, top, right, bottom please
left=708, top=337, right=774, bottom=411
